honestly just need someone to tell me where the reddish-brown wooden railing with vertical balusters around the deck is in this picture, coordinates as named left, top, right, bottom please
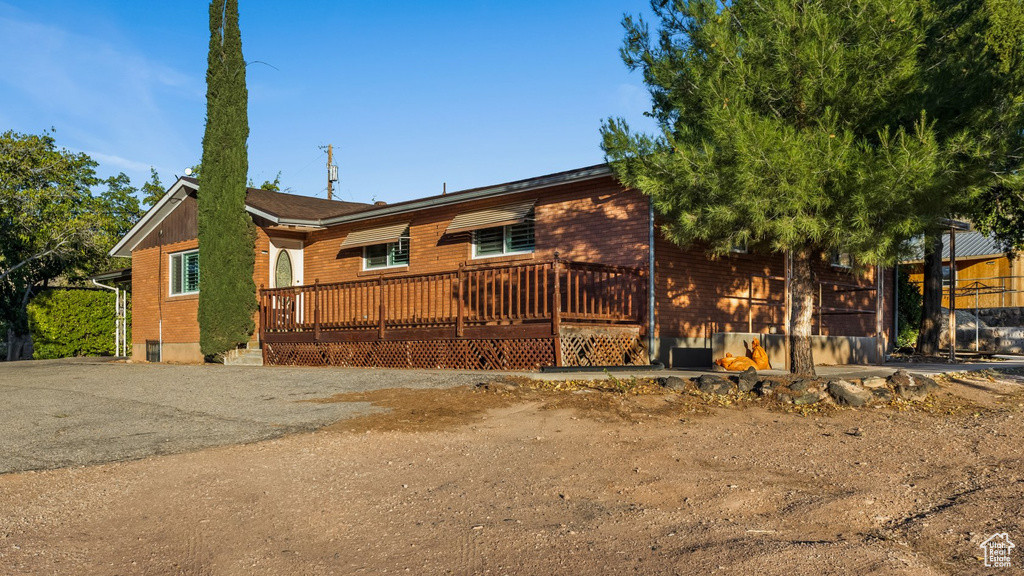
left=260, top=259, right=647, bottom=338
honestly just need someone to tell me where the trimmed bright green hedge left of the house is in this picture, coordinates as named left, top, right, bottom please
left=29, top=290, right=131, bottom=359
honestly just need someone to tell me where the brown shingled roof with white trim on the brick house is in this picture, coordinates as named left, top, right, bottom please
left=110, top=164, right=612, bottom=257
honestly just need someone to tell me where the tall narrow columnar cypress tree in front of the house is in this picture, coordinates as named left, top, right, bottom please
left=199, top=0, right=256, bottom=357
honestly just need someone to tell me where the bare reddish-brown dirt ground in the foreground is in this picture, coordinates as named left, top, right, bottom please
left=0, top=372, right=1024, bottom=575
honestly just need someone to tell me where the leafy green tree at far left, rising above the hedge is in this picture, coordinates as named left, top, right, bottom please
left=0, top=131, right=140, bottom=359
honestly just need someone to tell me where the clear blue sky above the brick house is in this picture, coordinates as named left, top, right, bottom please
left=0, top=0, right=653, bottom=202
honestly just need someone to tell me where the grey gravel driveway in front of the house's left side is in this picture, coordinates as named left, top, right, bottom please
left=0, top=359, right=481, bottom=474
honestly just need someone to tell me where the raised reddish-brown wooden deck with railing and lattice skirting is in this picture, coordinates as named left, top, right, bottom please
left=259, top=259, right=648, bottom=370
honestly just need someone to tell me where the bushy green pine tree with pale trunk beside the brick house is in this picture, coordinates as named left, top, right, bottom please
left=602, top=0, right=942, bottom=374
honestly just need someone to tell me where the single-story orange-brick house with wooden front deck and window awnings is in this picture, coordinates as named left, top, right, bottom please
left=111, top=164, right=894, bottom=369
